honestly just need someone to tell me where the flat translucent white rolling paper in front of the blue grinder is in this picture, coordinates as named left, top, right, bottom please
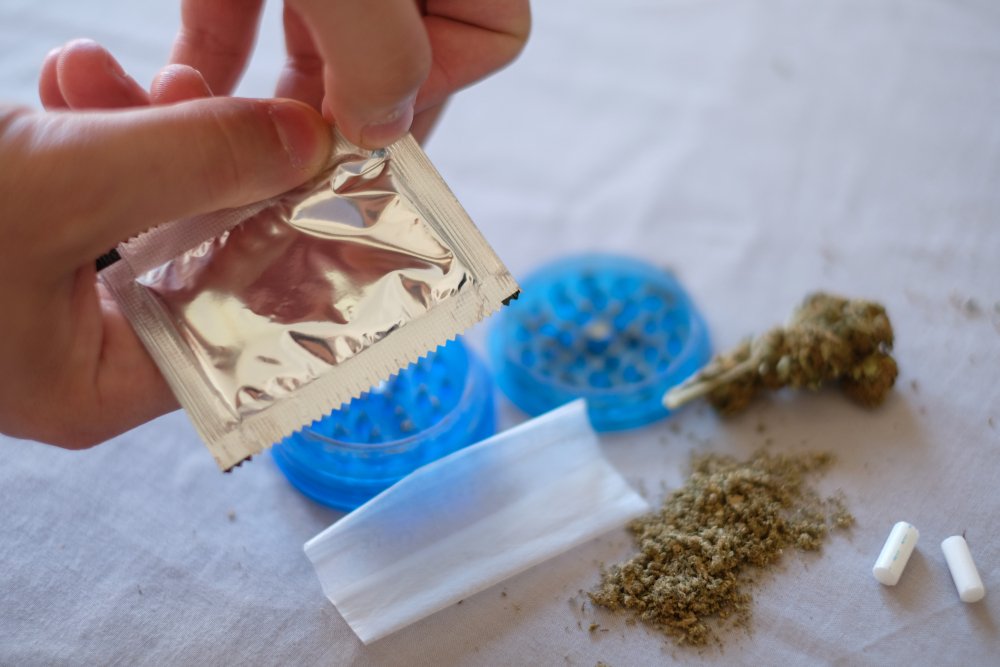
left=305, top=401, right=649, bottom=644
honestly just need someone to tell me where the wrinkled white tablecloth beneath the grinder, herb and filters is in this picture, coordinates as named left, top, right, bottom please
left=0, top=0, right=1000, bottom=667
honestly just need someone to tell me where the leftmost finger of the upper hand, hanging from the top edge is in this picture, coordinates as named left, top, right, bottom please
left=170, top=0, right=264, bottom=95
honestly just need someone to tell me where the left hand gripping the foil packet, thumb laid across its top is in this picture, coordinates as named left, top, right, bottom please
left=0, top=42, right=330, bottom=448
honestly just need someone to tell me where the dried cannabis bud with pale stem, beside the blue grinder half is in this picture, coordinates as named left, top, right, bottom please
left=663, top=292, right=898, bottom=415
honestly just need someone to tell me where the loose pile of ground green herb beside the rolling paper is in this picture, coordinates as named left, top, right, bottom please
left=590, top=453, right=854, bottom=645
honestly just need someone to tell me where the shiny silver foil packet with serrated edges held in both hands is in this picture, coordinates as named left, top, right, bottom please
left=99, top=135, right=518, bottom=470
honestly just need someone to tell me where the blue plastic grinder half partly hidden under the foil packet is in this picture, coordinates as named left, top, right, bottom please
left=271, top=341, right=496, bottom=510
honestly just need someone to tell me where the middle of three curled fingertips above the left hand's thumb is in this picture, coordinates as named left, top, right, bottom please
left=56, top=39, right=149, bottom=109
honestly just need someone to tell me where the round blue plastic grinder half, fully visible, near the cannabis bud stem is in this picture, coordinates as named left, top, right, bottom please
left=489, top=255, right=711, bottom=431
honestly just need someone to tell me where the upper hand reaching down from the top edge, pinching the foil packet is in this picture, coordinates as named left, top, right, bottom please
left=171, top=0, right=531, bottom=148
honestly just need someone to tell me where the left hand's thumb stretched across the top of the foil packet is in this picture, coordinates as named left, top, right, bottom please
left=0, top=98, right=332, bottom=261
